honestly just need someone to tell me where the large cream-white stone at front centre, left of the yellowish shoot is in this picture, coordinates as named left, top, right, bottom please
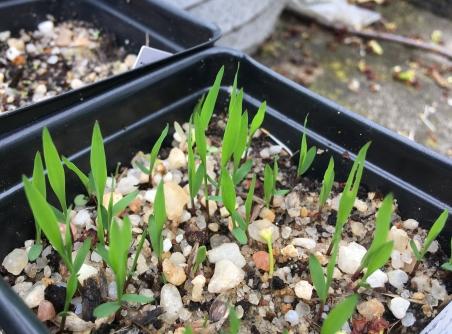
left=208, top=260, right=245, bottom=293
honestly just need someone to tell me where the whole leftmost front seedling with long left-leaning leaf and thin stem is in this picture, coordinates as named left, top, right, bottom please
left=22, top=176, right=91, bottom=330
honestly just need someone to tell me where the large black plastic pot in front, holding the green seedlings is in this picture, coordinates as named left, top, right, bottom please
left=0, top=48, right=452, bottom=333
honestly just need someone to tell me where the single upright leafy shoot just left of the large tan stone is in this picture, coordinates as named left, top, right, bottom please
left=148, top=181, right=166, bottom=261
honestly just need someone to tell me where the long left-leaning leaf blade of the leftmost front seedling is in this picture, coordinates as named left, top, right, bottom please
left=22, top=176, right=65, bottom=256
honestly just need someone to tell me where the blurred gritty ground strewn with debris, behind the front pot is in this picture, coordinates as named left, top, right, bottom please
left=254, top=0, right=452, bottom=157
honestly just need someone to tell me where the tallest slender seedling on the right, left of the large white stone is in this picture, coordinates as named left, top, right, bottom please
left=327, top=142, right=370, bottom=255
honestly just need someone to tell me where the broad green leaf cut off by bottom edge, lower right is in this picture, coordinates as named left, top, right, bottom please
left=320, top=294, right=358, bottom=334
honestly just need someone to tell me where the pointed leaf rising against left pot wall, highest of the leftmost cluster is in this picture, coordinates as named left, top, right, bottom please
left=42, top=128, right=67, bottom=213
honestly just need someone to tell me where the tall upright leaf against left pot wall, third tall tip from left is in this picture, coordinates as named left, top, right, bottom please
left=90, top=122, right=107, bottom=203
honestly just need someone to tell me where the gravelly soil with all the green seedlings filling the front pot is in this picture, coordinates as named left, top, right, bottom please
left=3, top=68, right=452, bottom=334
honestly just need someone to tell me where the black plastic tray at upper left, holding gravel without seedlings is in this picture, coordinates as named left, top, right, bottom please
left=0, top=0, right=220, bottom=121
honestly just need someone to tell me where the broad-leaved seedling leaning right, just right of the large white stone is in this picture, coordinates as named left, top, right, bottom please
left=352, top=194, right=394, bottom=282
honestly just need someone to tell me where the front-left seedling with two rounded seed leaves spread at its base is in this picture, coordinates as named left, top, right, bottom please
left=94, top=216, right=152, bottom=318
